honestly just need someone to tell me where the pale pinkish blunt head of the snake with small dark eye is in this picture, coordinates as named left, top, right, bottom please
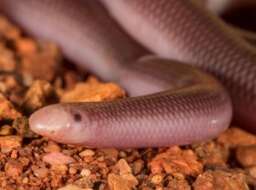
left=29, top=104, right=91, bottom=144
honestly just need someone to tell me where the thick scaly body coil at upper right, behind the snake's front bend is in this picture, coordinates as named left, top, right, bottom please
left=102, top=0, right=256, bottom=131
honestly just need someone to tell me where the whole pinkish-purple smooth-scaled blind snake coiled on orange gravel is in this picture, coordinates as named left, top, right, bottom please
left=0, top=0, right=256, bottom=147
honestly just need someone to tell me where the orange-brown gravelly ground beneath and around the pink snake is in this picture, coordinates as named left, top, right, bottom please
left=0, top=17, right=256, bottom=190
